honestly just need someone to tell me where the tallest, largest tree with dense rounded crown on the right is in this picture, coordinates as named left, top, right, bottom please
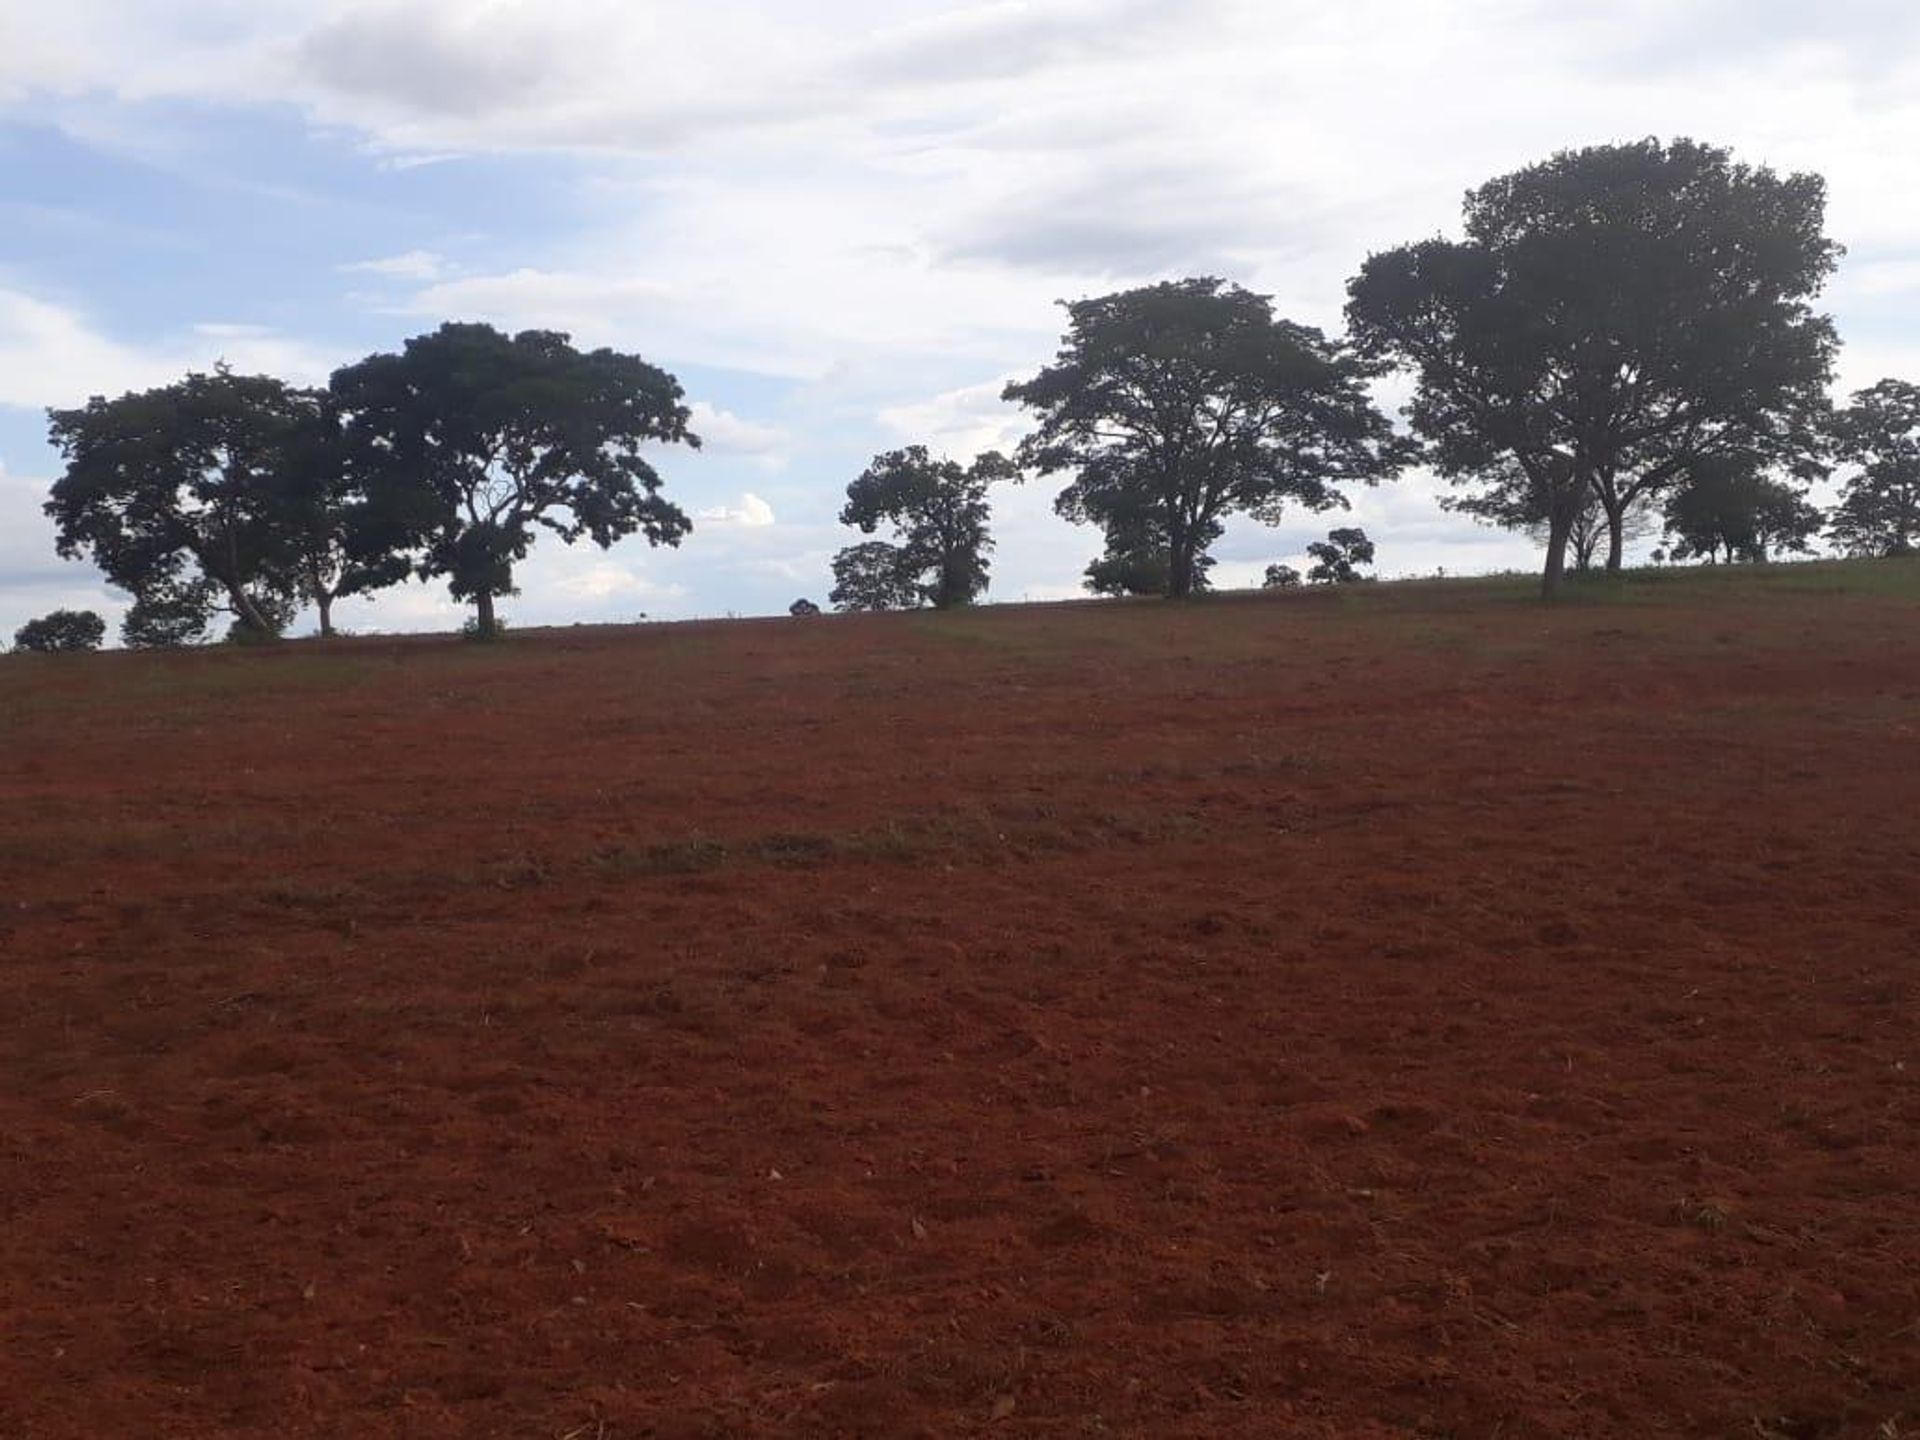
left=1346, top=140, right=1839, bottom=597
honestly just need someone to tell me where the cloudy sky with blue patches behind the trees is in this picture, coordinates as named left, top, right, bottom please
left=0, top=0, right=1920, bottom=634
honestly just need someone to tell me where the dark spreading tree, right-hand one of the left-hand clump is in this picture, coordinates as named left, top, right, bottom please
left=330, top=324, right=699, bottom=636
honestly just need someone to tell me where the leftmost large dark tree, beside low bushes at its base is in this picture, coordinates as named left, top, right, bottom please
left=46, top=367, right=309, bottom=643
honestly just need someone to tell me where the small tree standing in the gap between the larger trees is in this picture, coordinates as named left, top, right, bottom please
left=835, top=445, right=1014, bottom=611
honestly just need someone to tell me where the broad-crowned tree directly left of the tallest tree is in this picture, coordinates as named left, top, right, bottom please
left=1004, top=278, right=1407, bottom=599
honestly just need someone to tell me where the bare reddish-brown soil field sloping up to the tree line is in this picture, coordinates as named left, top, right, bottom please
left=0, top=586, right=1920, bottom=1440
